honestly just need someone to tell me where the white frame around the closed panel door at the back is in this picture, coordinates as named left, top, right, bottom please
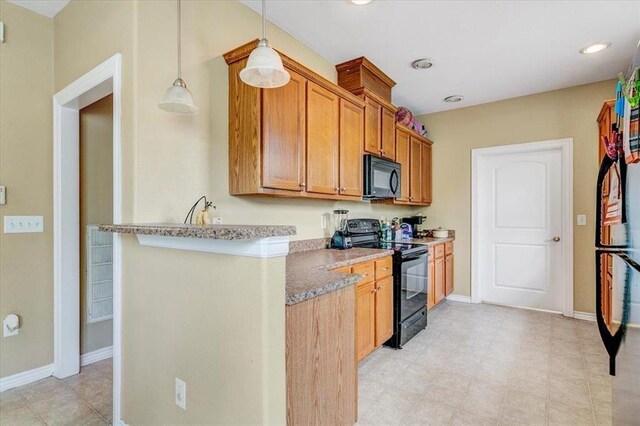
left=471, top=138, right=573, bottom=317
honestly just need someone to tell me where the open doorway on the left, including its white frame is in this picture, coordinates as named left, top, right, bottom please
left=53, top=54, right=122, bottom=424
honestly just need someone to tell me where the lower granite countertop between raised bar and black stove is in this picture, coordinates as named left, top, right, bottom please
left=285, top=248, right=393, bottom=305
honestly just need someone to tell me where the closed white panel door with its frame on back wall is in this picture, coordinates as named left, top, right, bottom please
left=471, top=139, right=573, bottom=317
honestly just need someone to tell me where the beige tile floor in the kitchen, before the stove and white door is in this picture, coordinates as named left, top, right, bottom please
left=358, top=301, right=612, bottom=426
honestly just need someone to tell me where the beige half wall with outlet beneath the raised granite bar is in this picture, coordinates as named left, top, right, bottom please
left=122, top=236, right=286, bottom=425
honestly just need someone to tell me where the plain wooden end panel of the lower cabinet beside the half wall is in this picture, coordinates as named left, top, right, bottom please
left=285, top=286, right=358, bottom=425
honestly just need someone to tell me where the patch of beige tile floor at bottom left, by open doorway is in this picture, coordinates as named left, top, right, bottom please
left=0, top=359, right=113, bottom=426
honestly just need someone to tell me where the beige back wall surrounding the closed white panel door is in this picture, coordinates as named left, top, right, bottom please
left=419, top=81, right=615, bottom=312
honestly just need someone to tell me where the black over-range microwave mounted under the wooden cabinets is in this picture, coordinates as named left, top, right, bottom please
left=363, top=155, right=400, bottom=200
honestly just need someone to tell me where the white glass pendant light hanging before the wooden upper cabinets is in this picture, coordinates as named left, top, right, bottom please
left=240, top=0, right=291, bottom=89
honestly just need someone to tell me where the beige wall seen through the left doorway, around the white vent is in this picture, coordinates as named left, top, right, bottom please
left=80, top=95, right=113, bottom=354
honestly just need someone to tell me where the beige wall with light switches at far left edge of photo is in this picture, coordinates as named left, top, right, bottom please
left=0, top=0, right=53, bottom=377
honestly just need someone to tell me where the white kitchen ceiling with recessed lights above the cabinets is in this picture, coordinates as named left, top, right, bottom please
left=241, top=0, right=640, bottom=114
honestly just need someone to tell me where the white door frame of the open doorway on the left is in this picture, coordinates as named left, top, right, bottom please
left=53, top=54, right=122, bottom=424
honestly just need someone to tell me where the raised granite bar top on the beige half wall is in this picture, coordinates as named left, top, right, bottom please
left=98, top=223, right=296, bottom=240
